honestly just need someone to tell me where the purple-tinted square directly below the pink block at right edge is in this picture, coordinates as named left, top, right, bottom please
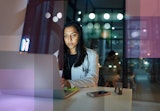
left=126, top=16, right=160, bottom=58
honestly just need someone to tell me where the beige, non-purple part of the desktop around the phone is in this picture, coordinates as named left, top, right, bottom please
left=54, top=87, right=132, bottom=111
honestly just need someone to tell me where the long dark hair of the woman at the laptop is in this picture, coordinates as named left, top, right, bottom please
left=63, top=21, right=87, bottom=68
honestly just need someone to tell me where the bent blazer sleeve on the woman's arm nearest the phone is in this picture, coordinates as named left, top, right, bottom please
left=69, top=50, right=99, bottom=88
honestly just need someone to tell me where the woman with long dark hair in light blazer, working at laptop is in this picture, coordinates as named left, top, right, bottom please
left=62, top=21, right=99, bottom=88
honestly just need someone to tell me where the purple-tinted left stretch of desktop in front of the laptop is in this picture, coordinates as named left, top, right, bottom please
left=0, top=94, right=53, bottom=111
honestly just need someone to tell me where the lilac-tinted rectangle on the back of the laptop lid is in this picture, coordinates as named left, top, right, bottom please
left=0, top=69, right=34, bottom=90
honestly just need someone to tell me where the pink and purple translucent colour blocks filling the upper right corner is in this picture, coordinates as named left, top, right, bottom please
left=126, top=0, right=160, bottom=58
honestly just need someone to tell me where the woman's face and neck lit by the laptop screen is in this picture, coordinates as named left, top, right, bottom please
left=64, top=26, right=79, bottom=54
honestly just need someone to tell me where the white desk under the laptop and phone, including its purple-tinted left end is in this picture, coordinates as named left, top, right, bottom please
left=0, top=87, right=132, bottom=111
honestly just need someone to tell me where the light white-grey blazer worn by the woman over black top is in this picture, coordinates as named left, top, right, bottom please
left=69, top=48, right=99, bottom=88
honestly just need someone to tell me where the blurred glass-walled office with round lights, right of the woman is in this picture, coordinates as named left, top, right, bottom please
left=66, top=0, right=160, bottom=105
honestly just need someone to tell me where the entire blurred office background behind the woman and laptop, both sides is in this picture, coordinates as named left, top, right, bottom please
left=0, top=0, right=160, bottom=110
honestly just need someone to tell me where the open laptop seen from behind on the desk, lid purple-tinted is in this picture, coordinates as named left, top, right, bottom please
left=0, top=51, right=79, bottom=99
